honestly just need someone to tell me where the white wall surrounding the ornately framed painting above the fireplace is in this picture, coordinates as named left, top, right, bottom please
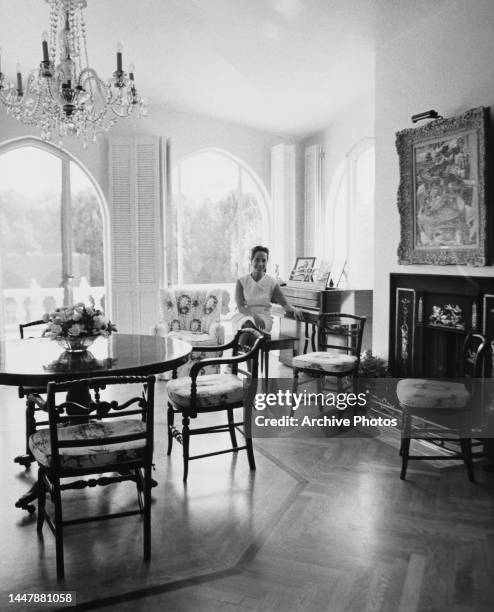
left=373, top=0, right=494, bottom=356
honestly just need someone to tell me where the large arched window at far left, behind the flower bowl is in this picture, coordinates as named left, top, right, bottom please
left=0, top=139, right=106, bottom=337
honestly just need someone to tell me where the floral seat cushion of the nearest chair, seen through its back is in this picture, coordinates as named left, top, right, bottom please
left=29, top=419, right=146, bottom=469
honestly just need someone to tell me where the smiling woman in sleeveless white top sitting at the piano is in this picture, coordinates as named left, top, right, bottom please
left=232, top=246, right=303, bottom=333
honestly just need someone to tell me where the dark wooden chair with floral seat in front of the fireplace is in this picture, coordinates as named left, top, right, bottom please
left=396, top=334, right=487, bottom=482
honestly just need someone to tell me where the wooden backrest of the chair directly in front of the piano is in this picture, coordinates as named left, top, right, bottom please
left=317, top=312, right=366, bottom=360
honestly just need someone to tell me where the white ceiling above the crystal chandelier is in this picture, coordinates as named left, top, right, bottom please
left=0, top=0, right=447, bottom=136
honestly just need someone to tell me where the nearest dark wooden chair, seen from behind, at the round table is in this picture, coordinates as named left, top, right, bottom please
left=29, top=376, right=155, bottom=578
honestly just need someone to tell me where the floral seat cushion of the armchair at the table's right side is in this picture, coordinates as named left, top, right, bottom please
left=166, top=374, right=244, bottom=408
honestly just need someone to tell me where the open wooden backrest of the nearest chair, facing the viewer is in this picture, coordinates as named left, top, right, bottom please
left=47, top=376, right=155, bottom=471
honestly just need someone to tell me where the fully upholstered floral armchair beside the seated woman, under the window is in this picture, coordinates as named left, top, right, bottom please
left=152, top=287, right=230, bottom=377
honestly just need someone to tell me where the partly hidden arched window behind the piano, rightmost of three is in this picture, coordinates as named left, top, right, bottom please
left=325, top=138, right=375, bottom=289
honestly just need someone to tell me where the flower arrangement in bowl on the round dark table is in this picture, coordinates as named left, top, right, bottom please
left=43, top=301, right=117, bottom=340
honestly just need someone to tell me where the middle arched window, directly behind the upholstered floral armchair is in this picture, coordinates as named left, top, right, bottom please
left=169, top=150, right=269, bottom=284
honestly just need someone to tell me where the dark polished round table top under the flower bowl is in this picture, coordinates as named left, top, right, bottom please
left=0, top=334, right=192, bottom=386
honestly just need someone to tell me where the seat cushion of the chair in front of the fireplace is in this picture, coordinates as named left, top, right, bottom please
left=396, top=378, right=470, bottom=410
